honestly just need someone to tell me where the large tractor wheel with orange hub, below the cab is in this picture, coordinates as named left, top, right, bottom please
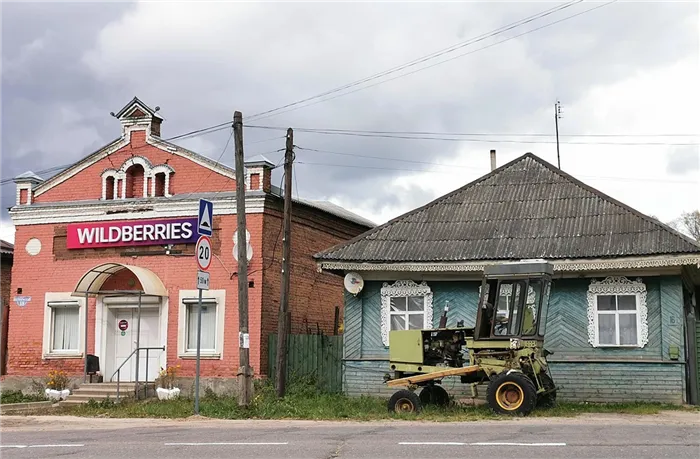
left=486, top=371, right=537, bottom=416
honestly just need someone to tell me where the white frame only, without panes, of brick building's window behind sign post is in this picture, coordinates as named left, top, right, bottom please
left=177, top=290, right=226, bottom=359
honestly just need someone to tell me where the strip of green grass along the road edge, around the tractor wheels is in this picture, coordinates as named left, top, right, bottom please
left=58, top=382, right=700, bottom=421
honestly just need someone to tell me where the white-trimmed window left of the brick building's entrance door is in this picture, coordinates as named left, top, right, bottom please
left=43, top=292, right=85, bottom=358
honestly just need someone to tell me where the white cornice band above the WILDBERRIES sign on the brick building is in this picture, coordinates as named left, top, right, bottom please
left=9, top=196, right=265, bottom=226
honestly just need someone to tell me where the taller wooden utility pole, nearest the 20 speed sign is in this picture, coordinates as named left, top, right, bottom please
left=233, top=111, right=253, bottom=406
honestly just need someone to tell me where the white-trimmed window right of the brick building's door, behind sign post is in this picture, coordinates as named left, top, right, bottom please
left=178, top=290, right=226, bottom=359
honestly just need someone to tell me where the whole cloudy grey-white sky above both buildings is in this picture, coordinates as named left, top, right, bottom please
left=0, top=0, right=700, bottom=241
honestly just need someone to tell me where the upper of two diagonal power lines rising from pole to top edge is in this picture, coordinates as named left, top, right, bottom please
left=248, top=0, right=581, bottom=119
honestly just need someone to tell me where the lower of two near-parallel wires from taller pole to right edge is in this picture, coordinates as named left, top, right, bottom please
left=248, top=125, right=700, bottom=146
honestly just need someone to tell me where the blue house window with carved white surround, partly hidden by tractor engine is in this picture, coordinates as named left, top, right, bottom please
left=381, top=280, right=433, bottom=346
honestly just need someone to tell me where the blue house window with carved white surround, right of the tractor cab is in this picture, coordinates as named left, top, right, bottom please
left=588, top=277, right=649, bottom=347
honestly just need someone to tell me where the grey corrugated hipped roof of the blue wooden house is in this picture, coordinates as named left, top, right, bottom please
left=316, top=153, right=700, bottom=263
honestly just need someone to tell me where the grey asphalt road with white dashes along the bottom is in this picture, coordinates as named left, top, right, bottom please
left=0, top=419, right=700, bottom=459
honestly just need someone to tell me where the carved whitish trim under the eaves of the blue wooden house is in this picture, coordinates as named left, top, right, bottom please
left=318, top=255, right=700, bottom=272
